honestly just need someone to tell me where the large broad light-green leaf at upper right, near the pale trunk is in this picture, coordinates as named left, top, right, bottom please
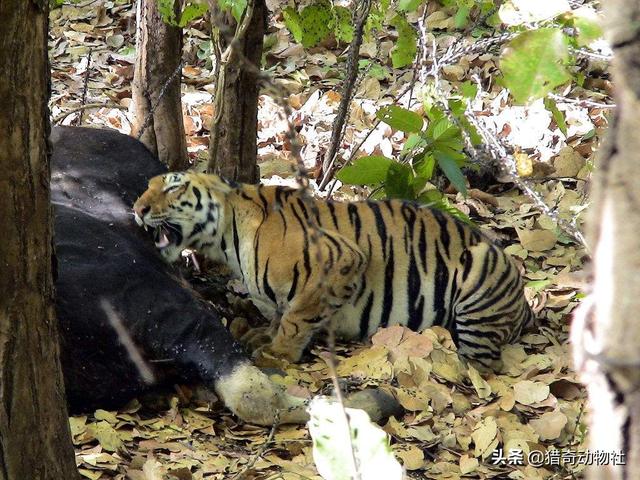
left=500, top=28, right=571, bottom=104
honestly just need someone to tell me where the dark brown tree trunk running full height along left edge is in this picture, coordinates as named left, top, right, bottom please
left=0, top=0, right=78, bottom=480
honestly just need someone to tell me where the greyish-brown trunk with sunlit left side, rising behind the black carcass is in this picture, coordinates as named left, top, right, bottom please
left=132, top=0, right=189, bottom=170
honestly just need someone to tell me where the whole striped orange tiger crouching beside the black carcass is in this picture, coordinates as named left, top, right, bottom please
left=133, top=172, right=534, bottom=368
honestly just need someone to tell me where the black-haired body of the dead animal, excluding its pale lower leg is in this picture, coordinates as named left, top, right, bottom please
left=51, top=127, right=247, bottom=411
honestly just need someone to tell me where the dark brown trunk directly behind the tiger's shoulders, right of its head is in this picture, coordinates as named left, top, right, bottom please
left=208, top=0, right=267, bottom=183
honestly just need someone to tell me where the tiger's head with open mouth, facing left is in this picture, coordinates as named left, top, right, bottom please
left=133, top=172, right=232, bottom=262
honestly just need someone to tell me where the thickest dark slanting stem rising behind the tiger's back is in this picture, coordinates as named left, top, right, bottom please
left=319, top=0, right=371, bottom=190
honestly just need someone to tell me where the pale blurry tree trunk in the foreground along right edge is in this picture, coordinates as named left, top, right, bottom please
left=572, top=0, right=640, bottom=480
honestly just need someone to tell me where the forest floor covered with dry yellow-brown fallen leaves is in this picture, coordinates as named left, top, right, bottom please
left=50, top=0, right=610, bottom=480
